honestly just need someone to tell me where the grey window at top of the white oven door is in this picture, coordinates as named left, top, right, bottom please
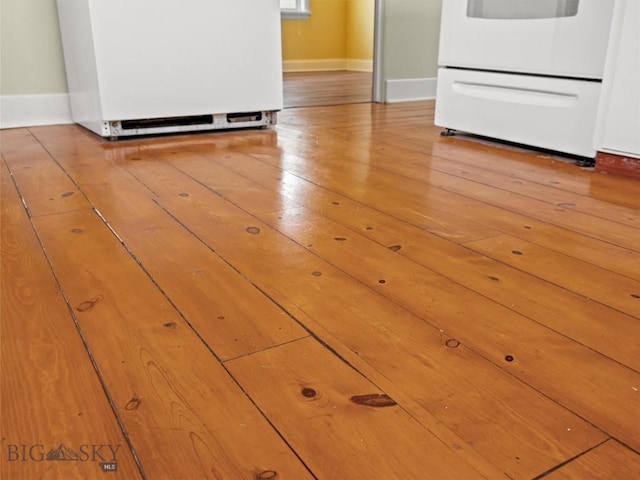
left=467, top=0, right=580, bottom=20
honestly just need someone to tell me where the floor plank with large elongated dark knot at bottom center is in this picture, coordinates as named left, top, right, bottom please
left=227, top=339, right=485, bottom=480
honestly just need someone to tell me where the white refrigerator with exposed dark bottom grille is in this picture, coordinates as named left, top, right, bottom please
left=57, top=0, right=283, bottom=139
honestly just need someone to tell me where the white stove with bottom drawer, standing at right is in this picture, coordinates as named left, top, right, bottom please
left=435, top=0, right=614, bottom=158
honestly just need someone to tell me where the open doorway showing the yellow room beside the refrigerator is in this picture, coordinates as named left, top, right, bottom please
left=282, top=0, right=382, bottom=108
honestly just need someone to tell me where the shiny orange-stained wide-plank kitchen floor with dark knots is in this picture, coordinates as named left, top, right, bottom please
left=0, top=94, right=640, bottom=480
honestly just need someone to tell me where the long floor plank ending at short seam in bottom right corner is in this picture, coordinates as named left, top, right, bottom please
left=126, top=163, right=601, bottom=477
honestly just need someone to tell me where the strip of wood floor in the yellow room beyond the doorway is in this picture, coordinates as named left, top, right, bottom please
left=283, top=70, right=373, bottom=108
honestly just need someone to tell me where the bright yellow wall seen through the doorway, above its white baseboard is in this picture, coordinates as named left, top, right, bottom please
left=282, top=0, right=375, bottom=69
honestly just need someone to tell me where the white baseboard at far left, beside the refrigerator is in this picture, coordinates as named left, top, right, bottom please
left=0, top=93, right=73, bottom=128
